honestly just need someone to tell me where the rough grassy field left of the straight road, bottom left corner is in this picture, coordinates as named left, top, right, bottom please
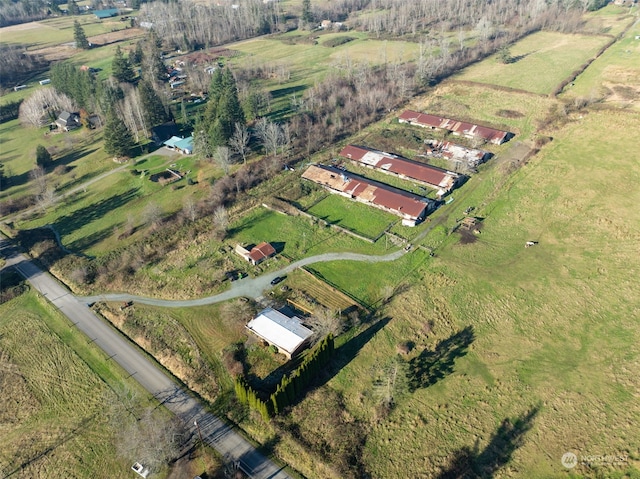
left=0, top=293, right=131, bottom=479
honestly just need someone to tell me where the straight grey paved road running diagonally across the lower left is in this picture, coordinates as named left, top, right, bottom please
left=0, top=236, right=290, bottom=479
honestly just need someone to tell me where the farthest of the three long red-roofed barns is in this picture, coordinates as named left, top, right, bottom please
left=398, top=110, right=514, bottom=145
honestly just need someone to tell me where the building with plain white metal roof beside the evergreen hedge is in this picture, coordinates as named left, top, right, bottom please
left=246, top=308, right=313, bottom=359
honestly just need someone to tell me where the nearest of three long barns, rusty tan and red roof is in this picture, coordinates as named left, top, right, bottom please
left=302, top=165, right=436, bottom=226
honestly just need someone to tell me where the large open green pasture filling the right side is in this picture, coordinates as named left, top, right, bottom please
left=316, top=112, right=640, bottom=478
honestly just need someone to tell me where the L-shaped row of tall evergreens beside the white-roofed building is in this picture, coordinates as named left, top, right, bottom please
left=235, top=334, right=334, bottom=421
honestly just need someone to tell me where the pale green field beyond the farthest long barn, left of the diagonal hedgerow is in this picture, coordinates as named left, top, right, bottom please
left=454, top=32, right=611, bottom=95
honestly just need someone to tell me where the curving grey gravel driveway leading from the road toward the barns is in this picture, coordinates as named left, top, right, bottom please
left=77, top=249, right=407, bottom=308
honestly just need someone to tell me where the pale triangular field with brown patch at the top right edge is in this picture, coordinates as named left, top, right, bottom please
left=562, top=18, right=640, bottom=110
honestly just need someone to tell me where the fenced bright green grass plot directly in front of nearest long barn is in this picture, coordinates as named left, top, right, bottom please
left=307, top=195, right=396, bottom=239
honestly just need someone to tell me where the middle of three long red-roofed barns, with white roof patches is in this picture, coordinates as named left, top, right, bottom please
left=340, top=145, right=461, bottom=196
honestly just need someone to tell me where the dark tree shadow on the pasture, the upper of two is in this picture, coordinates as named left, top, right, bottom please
left=408, top=326, right=475, bottom=392
